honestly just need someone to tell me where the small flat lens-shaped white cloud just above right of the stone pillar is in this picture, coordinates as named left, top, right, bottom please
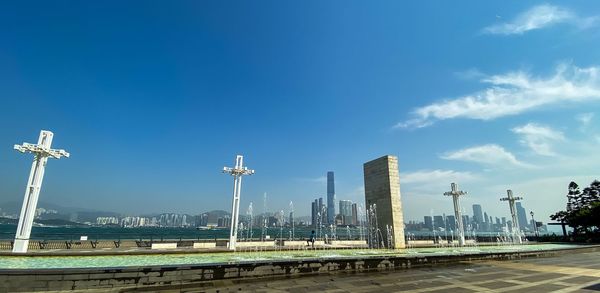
left=441, top=144, right=530, bottom=167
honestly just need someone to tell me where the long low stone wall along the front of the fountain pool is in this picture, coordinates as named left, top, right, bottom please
left=0, top=246, right=600, bottom=292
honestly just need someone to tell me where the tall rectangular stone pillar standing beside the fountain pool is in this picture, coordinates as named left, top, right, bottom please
left=363, top=155, right=405, bottom=249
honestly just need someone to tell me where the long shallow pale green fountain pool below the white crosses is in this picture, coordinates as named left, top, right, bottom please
left=0, top=244, right=579, bottom=270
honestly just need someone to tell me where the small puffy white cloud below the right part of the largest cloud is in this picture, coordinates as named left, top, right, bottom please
left=511, top=123, right=565, bottom=156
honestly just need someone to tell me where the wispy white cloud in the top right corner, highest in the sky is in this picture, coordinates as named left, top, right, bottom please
left=482, top=5, right=598, bottom=35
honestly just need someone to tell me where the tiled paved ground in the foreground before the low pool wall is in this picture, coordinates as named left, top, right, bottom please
left=137, top=252, right=600, bottom=293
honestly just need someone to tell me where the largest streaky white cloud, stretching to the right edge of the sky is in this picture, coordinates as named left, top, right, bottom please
left=394, top=64, right=600, bottom=128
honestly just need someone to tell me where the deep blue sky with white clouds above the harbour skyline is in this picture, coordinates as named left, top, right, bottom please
left=0, top=1, right=600, bottom=220
